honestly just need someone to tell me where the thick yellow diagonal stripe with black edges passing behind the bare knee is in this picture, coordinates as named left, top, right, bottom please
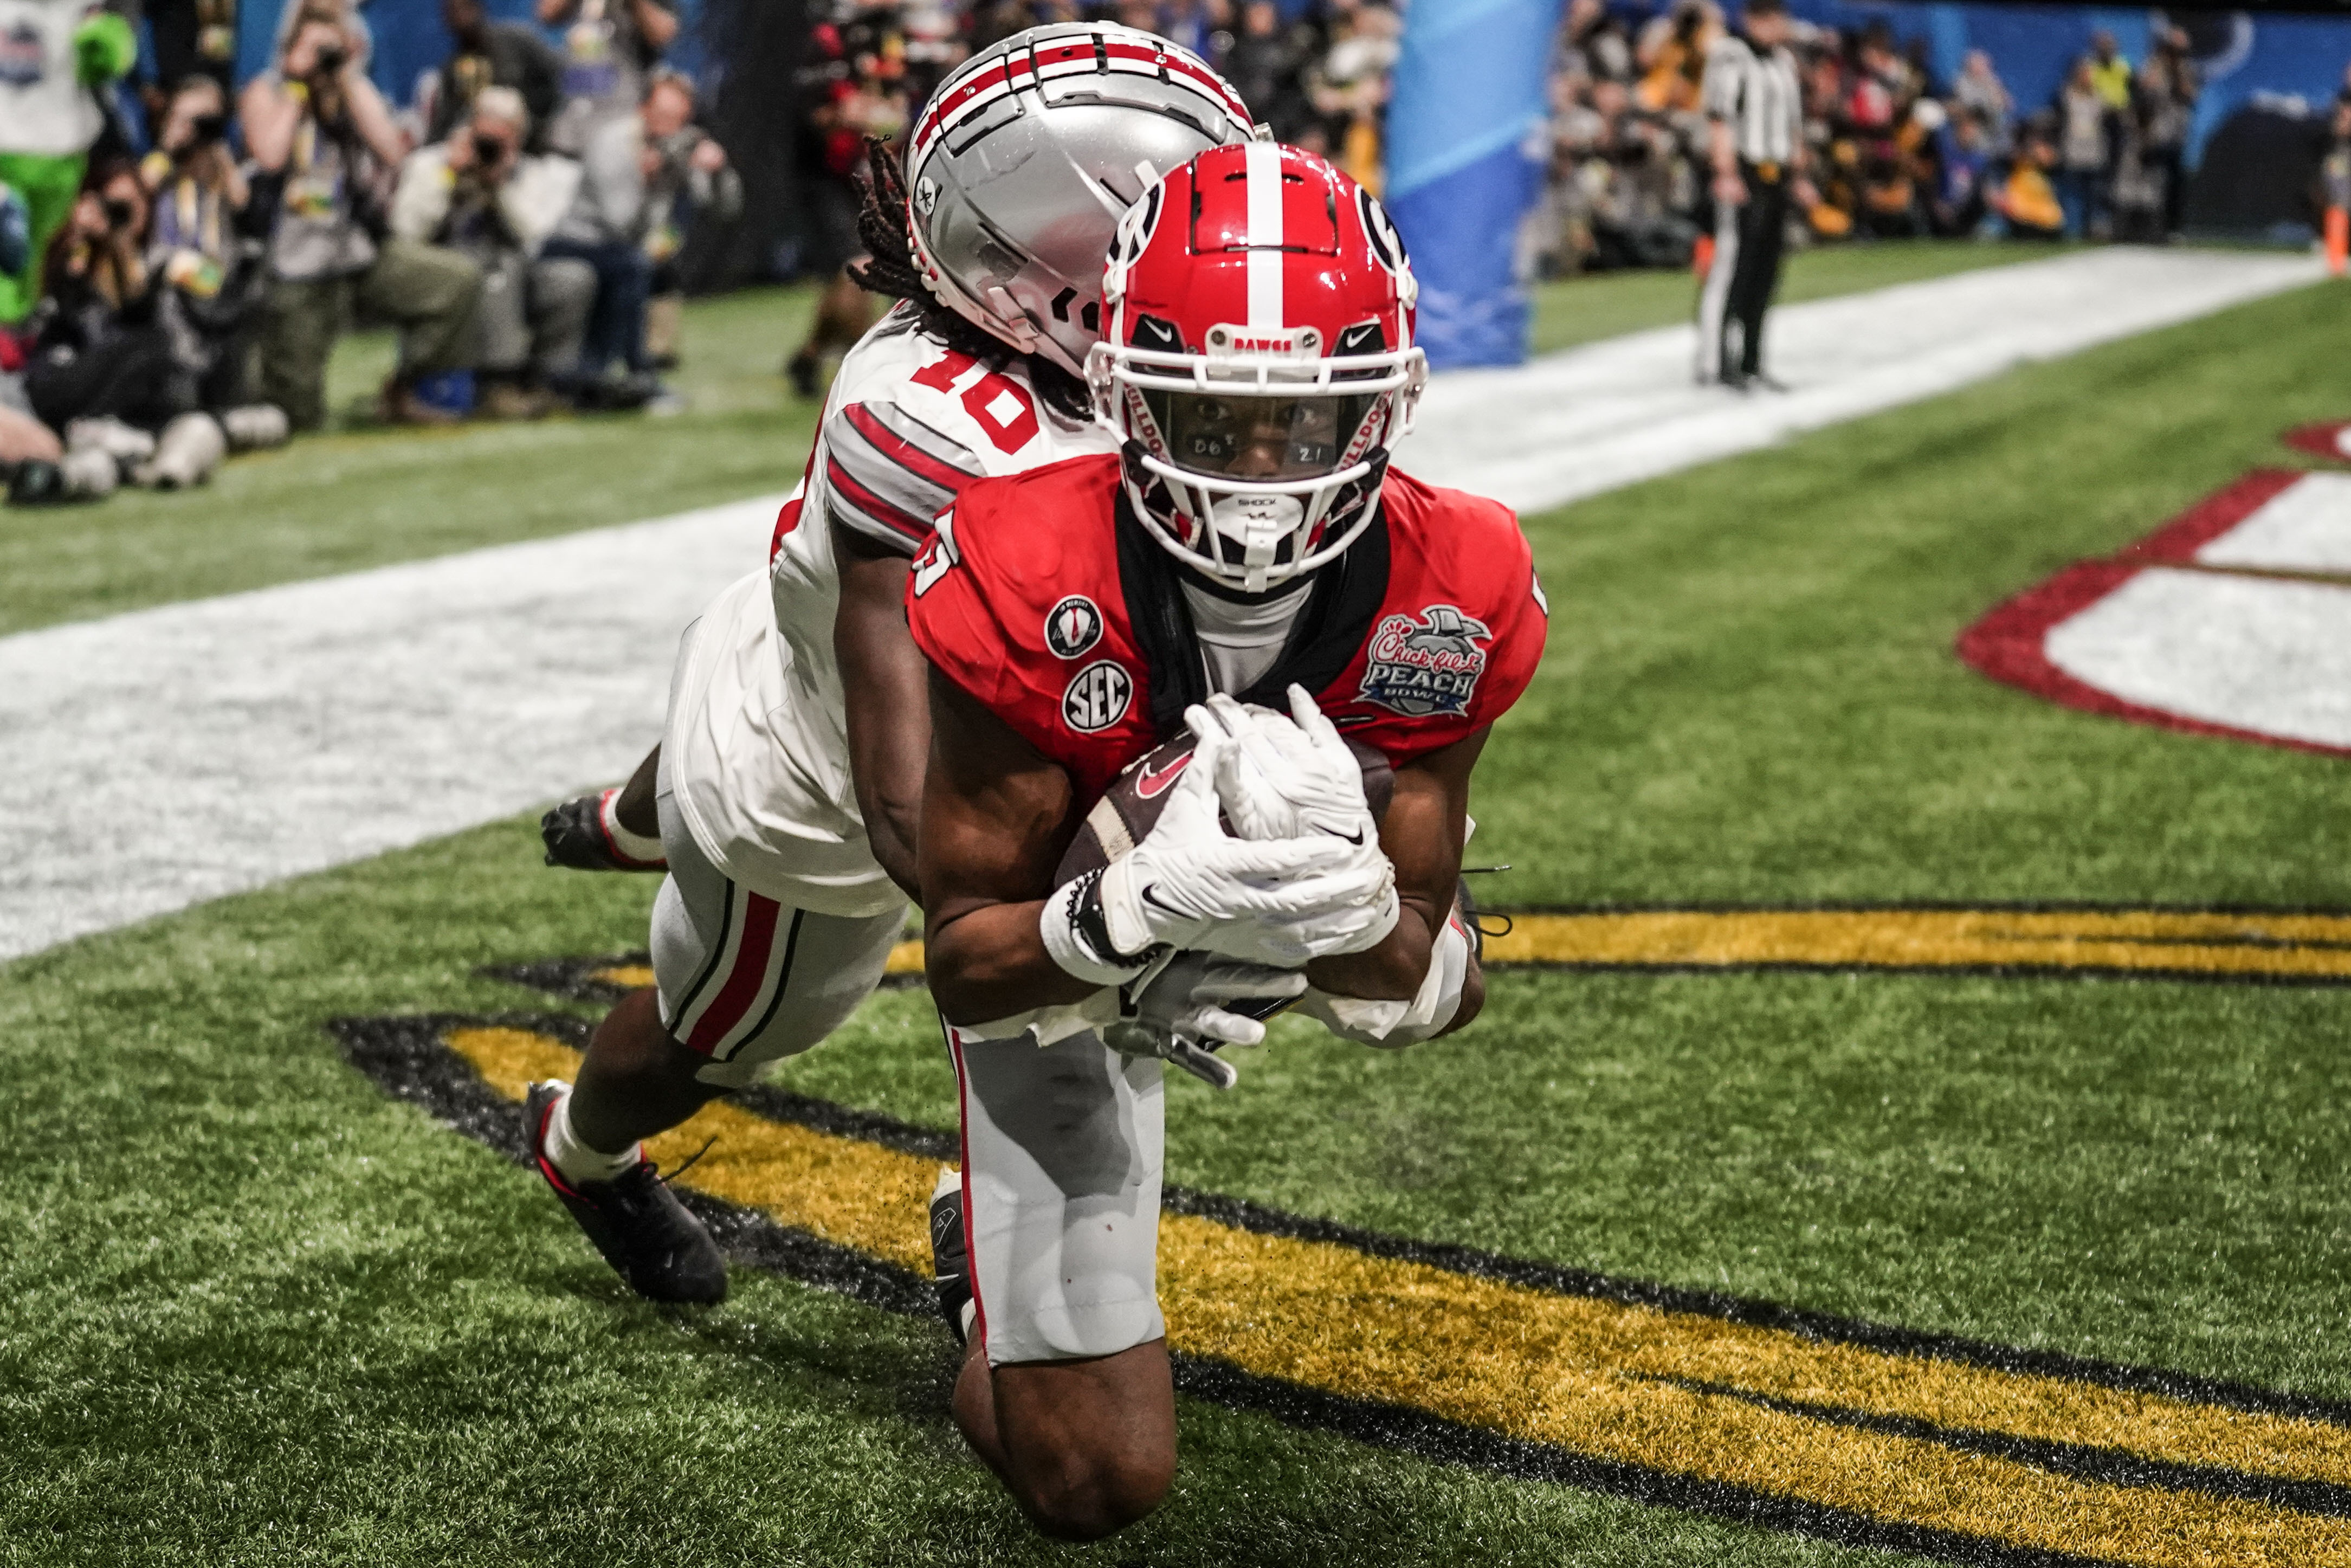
left=447, top=1027, right=2351, bottom=1568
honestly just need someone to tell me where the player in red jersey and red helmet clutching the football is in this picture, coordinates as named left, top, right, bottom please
left=907, top=144, right=1545, bottom=1538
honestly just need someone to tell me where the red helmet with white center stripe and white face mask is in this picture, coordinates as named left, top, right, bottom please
left=1086, top=141, right=1427, bottom=592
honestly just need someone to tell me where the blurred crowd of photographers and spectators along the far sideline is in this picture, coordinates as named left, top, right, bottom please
left=0, top=0, right=2276, bottom=501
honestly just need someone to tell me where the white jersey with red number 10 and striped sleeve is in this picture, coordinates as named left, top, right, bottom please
left=663, top=306, right=1117, bottom=914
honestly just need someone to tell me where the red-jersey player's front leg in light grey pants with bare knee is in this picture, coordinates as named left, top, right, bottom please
left=950, top=1032, right=1176, bottom=1540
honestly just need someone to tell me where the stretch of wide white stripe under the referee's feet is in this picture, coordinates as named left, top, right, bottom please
left=1397, top=247, right=2325, bottom=513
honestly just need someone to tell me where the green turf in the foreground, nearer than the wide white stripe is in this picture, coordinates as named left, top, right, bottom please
left=0, top=267, right=2351, bottom=1568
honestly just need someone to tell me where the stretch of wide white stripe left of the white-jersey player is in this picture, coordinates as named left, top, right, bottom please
left=0, top=496, right=783, bottom=959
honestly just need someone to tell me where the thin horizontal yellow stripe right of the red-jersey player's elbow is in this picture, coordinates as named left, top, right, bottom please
left=1486, top=910, right=2351, bottom=978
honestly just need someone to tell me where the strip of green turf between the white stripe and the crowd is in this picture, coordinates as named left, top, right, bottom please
left=0, top=244, right=2040, bottom=637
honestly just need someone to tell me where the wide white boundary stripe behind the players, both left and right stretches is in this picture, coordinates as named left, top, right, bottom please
left=0, top=251, right=2318, bottom=959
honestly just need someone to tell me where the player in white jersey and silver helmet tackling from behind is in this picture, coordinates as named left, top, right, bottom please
left=524, top=23, right=1251, bottom=1302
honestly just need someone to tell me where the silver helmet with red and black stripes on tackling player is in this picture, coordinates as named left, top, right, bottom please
left=905, top=21, right=1253, bottom=376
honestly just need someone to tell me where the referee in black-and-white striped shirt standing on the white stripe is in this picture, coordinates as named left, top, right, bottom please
left=1697, top=0, right=1815, bottom=392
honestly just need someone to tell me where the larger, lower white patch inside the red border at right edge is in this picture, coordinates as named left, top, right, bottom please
left=2043, top=566, right=2351, bottom=745
